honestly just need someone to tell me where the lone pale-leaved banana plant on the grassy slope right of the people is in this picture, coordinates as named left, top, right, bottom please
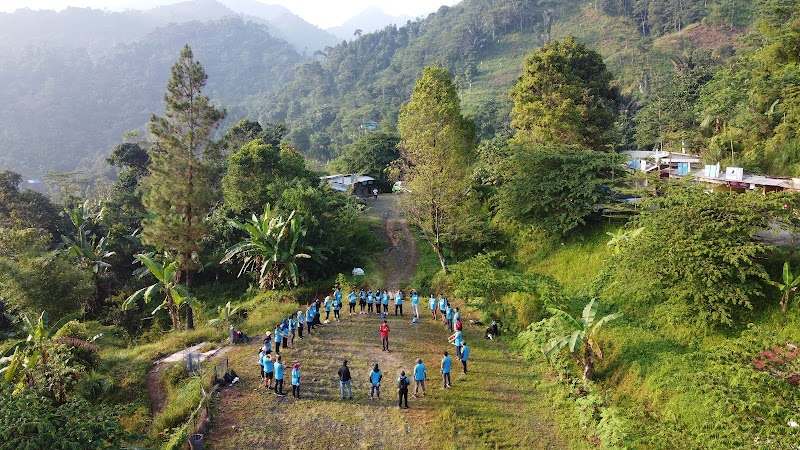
left=542, top=299, right=622, bottom=380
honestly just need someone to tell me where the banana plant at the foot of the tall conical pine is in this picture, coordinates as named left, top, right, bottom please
left=122, top=253, right=193, bottom=330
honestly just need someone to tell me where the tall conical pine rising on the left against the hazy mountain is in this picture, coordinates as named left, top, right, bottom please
left=142, top=45, right=225, bottom=328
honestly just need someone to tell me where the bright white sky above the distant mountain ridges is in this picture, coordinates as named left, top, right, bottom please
left=0, top=0, right=459, bottom=28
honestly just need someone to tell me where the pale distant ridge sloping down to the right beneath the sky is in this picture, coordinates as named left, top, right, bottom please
left=220, top=0, right=339, bottom=56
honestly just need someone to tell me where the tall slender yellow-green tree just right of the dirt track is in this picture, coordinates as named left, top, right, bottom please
left=398, top=66, right=479, bottom=273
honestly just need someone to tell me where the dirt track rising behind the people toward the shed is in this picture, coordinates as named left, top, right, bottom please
left=367, top=194, right=419, bottom=290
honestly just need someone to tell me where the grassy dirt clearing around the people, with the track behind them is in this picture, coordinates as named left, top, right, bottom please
left=205, top=195, right=569, bottom=450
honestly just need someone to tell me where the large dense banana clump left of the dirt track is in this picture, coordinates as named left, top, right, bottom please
left=220, top=203, right=313, bottom=290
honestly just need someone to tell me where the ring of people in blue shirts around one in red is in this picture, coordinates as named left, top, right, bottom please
left=253, top=288, right=470, bottom=408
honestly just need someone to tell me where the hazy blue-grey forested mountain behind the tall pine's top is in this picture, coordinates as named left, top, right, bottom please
left=0, top=17, right=304, bottom=178
